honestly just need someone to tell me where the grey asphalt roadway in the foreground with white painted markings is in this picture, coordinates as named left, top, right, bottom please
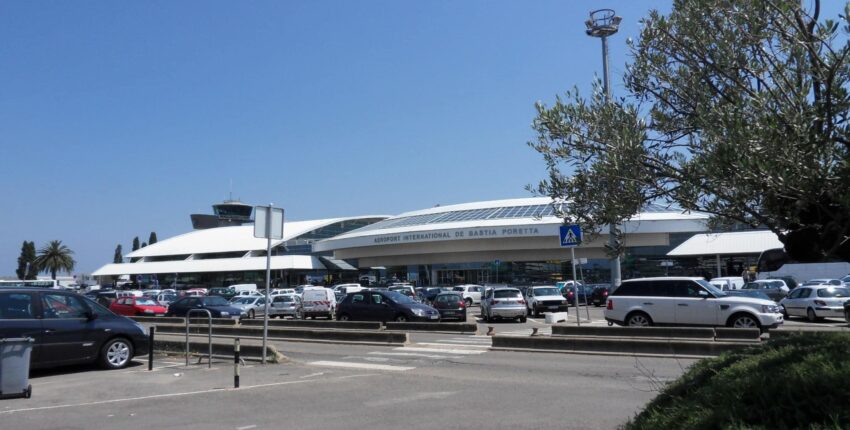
left=0, top=334, right=692, bottom=430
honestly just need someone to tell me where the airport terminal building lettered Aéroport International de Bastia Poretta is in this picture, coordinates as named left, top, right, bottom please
left=93, top=197, right=708, bottom=286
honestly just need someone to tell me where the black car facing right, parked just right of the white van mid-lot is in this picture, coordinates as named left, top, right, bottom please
left=336, top=290, right=440, bottom=322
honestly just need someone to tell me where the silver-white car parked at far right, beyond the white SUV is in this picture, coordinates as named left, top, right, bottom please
left=779, top=284, right=850, bottom=322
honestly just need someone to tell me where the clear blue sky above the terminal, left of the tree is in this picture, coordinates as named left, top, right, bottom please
left=0, top=0, right=669, bottom=275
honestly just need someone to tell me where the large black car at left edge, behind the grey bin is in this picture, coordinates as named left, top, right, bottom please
left=0, top=288, right=150, bottom=369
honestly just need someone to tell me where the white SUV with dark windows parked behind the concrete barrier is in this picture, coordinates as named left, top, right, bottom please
left=605, top=277, right=783, bottom=329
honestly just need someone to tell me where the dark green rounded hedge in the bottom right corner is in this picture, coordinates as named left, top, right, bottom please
left=623, top=332, right=850, bottom=430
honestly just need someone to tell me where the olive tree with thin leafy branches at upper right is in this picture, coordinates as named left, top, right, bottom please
left=531, top=0, right=850, bottom=261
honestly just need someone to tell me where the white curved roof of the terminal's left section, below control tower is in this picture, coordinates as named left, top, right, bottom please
left=126, top=215, right=386, bottom=258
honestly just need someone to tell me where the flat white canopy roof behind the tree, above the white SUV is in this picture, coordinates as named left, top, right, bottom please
left=667, top=230, right=785, bottom=257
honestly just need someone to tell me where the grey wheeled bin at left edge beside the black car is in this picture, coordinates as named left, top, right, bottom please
left=0, top=337, right=33, bottom=399
